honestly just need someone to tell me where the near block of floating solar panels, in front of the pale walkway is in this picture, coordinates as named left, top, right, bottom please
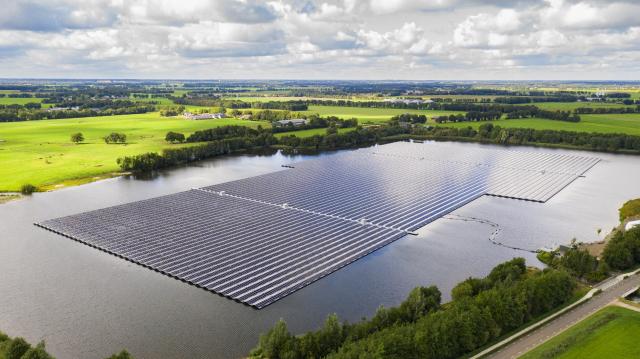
left=40, top=190, right=404, bottom=308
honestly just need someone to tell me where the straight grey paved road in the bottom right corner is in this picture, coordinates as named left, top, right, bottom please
left=487, top=274, right=640, bottom=359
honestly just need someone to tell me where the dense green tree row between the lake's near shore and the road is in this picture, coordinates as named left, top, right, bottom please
left=250, top=258, right=576, bottom=359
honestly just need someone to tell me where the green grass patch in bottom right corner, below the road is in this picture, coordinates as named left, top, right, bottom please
left=521, top=307, right=640, bottom=359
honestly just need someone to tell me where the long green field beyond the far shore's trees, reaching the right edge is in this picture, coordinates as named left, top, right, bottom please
left=438, top=114, right=640, bottom=136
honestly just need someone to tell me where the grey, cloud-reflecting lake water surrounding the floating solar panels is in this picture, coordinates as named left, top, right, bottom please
left=0, top=144, right=640, bottom=358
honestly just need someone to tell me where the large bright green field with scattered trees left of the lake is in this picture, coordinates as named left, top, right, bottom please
left=0, top=112, right=269, bottom=191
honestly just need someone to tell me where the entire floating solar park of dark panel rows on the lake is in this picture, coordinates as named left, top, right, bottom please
left=36, top=142, right=598, bottom=308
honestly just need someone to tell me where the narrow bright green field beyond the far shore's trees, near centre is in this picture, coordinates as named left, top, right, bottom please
left=302, top=106, right=462, bottom=123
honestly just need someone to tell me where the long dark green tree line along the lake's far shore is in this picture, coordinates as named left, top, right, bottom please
left=118, top=123, right=640, bottom=175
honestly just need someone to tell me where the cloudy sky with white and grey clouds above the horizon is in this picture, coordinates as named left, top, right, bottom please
left=0, top=0, right=640, bottom=80
